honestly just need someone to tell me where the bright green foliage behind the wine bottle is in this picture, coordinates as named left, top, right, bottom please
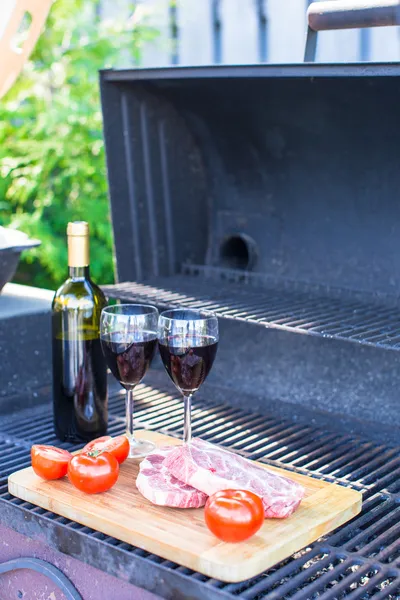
left=0, top=0, right=155, bottom=288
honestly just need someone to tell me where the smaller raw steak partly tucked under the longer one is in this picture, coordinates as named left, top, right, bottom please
left=136, top=446, right=207, bottom=508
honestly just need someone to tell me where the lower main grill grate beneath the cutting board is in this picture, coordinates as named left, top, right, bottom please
left=0, top=375, right=400, bottom=600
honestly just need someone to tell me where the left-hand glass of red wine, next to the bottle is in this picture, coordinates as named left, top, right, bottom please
left=100, top=304, right=158, bottom=458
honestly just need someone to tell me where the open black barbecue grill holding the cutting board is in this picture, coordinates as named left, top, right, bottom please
left=0, top=2, right=400, bottom=600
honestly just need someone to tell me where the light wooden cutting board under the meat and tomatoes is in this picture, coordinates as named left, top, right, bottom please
left=8, top=431, right=362, bottom=582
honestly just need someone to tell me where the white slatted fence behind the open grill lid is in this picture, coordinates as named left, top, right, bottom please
left=102, top=0, right=400, bottom=66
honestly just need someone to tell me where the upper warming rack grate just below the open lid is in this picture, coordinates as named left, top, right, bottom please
left=103, top=266, right=400, bottom=350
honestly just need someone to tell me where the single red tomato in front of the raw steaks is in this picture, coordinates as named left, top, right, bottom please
left=204, top=490, right=264, bottom=542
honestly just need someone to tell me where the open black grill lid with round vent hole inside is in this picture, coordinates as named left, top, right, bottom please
left=101, top=64, right=400, bottom=296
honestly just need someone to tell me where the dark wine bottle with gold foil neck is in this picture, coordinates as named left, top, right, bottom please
left=52, top=221, right=108, bottom=442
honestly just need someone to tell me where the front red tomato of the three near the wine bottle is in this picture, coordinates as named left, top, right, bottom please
left=68, top=452, right=119, bottom=494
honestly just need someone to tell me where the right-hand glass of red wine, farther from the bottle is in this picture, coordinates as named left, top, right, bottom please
left=158, top=309, right=219, bottom=444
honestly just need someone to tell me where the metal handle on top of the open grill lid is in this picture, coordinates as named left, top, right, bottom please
left=304, top=0, right=400, bottom=62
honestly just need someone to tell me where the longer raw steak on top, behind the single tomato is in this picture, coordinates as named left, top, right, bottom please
left=163, top=438, right=304, bottom=519
